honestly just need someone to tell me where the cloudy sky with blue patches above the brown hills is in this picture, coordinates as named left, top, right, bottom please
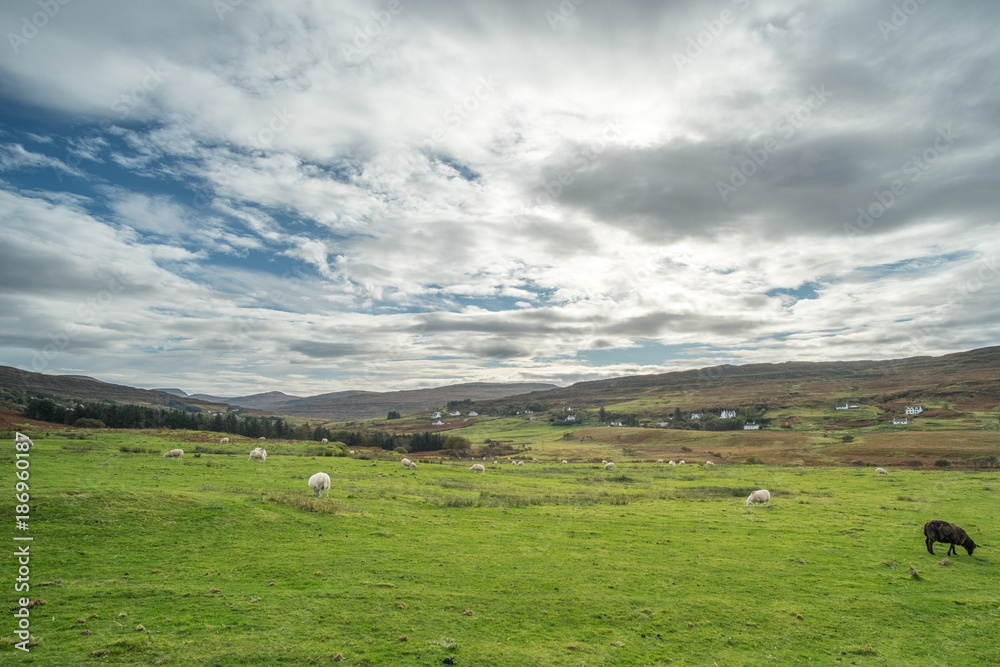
left=0, top=0, right=1000, bottom=396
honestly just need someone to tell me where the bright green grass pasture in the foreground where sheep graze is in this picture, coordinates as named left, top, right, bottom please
left=0, top=429, right=1000, bottom=667
